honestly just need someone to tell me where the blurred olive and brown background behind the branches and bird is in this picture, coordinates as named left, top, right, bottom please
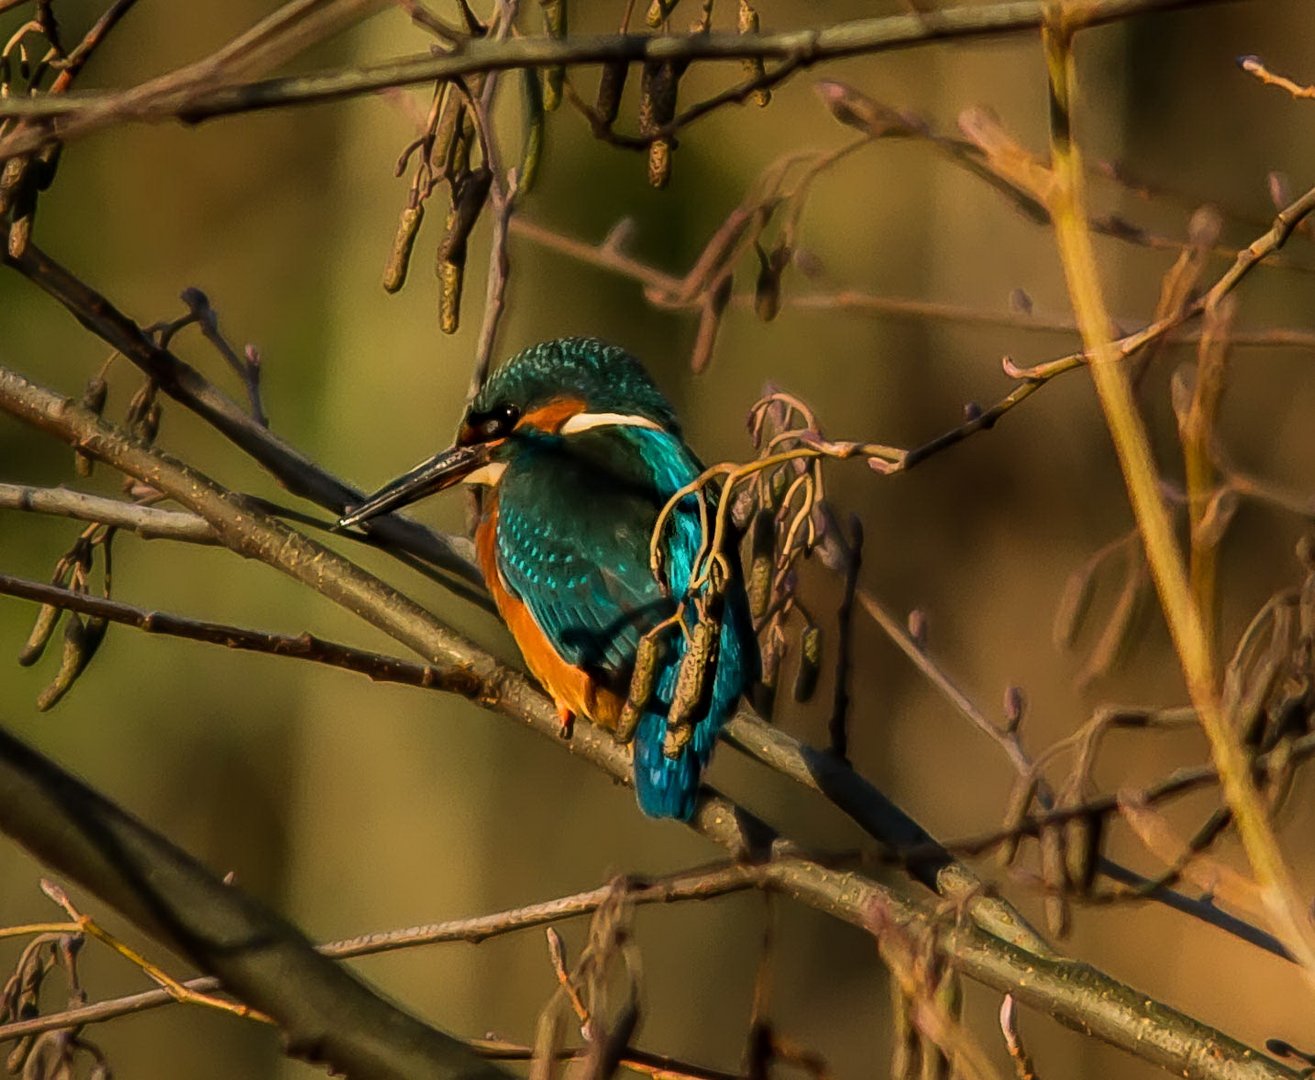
left=0, top=0, right=1315, bottom=1080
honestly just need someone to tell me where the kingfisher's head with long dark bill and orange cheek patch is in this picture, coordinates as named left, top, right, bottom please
left=338, top=338, right=680, bottom=529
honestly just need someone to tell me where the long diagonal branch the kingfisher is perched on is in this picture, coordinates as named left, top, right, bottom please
left=0, top=368, right=1291, bottom=1080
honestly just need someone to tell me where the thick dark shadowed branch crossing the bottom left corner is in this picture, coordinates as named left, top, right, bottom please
left=0, top=730, right=506, bottom=1080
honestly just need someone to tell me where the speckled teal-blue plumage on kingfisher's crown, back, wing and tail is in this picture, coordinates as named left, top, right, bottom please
left=486, top=339, right=757, bottom=820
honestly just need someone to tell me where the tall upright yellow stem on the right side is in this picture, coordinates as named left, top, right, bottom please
left=1041, top=8, right=1315, bottom=979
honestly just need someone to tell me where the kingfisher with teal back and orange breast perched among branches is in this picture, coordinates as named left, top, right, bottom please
left=338, top=338, right=759, bottom=821
